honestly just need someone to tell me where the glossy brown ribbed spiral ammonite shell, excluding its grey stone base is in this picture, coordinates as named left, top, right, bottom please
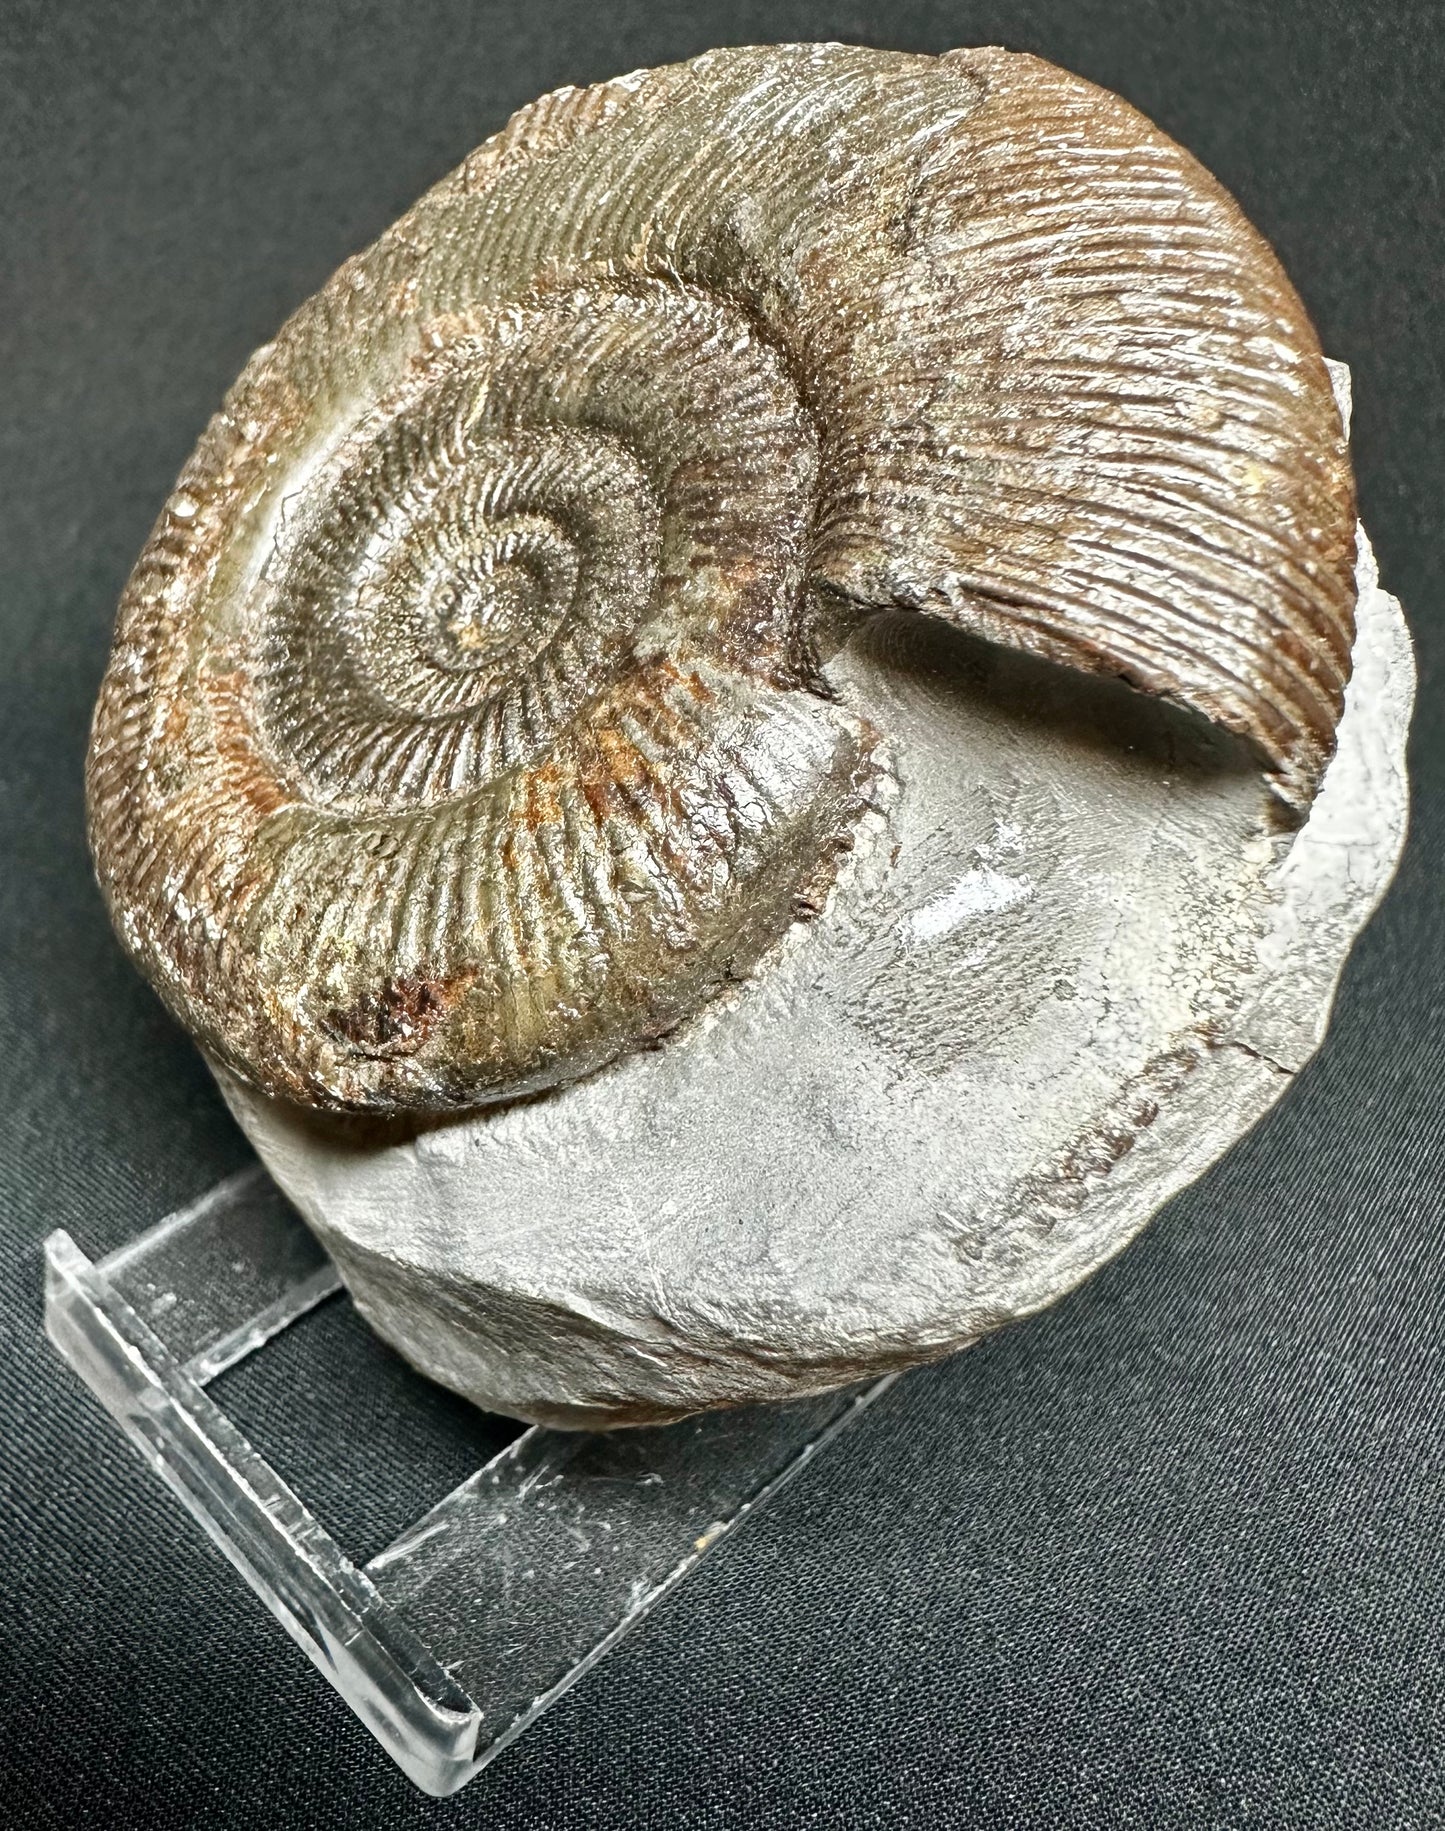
left=90, top=46, right=1353, bottom=1111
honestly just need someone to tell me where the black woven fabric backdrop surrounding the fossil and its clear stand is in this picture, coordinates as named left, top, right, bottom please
left=0, top=0, right=1445, bottom=1831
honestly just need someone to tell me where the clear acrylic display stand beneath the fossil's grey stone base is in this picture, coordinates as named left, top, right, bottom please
left=46, top=1168, right=890, bottom=1794
